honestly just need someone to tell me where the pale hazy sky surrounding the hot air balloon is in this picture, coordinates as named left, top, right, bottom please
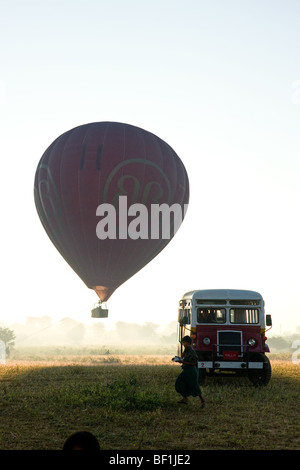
left=0, top=0, right=300, bottom=334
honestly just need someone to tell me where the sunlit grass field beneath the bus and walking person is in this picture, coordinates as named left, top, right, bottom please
left=0, top=354, right=300, bottom=450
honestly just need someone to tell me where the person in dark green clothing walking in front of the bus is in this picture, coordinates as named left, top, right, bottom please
left=172, top=336, right=205, bottom=408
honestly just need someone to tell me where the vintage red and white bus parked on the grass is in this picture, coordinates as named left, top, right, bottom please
left=178, top=289, right=272, bottom=385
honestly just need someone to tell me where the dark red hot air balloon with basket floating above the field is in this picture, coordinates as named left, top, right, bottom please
left=34, top=122, right=189, bottom=316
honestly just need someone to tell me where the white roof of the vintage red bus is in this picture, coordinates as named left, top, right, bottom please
left=182, top=289, right=262, bottom=300
